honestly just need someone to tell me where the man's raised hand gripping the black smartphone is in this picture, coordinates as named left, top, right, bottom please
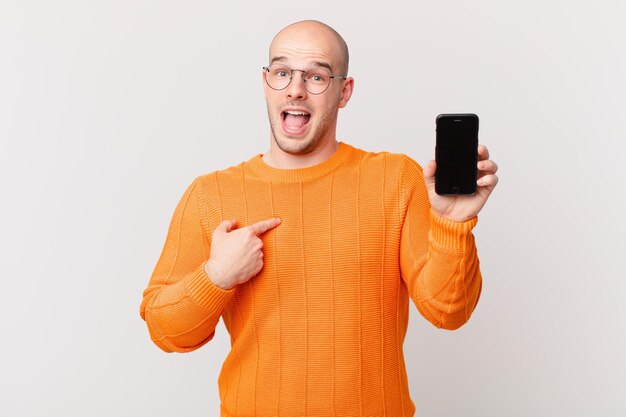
left=422, top=145, right=498, bottom=222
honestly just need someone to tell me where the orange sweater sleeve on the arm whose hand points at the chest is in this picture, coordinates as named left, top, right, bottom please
left=140, top=178, right=235, bottom=352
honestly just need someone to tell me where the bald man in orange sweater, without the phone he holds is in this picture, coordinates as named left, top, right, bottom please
left=141, top=21, right=497, bottom=416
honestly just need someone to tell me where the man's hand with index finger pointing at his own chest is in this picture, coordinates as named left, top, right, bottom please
left=204, top=218, right=280, bottom=290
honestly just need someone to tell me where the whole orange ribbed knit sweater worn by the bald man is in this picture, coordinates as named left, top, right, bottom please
left=141, top=142, right=482, bottom=417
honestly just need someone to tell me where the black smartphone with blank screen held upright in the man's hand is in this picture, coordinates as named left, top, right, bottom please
left=435, top=113, right=478, bottom=195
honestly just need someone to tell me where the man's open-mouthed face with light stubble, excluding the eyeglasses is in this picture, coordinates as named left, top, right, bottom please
left=263, top=28, right=347, bottom=155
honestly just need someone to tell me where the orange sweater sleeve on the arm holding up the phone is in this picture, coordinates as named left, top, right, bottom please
left=400, top=157, right=482, bottom=330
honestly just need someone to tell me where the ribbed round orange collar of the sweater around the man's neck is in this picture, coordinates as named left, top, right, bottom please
left=245, top=142, right=355, bottom=183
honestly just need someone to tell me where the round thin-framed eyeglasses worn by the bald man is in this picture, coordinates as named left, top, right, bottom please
left=263, top=63, right=348, bottom=94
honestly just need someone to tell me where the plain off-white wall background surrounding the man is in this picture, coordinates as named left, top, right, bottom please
left=0, top=0, right=626, bottom=416
